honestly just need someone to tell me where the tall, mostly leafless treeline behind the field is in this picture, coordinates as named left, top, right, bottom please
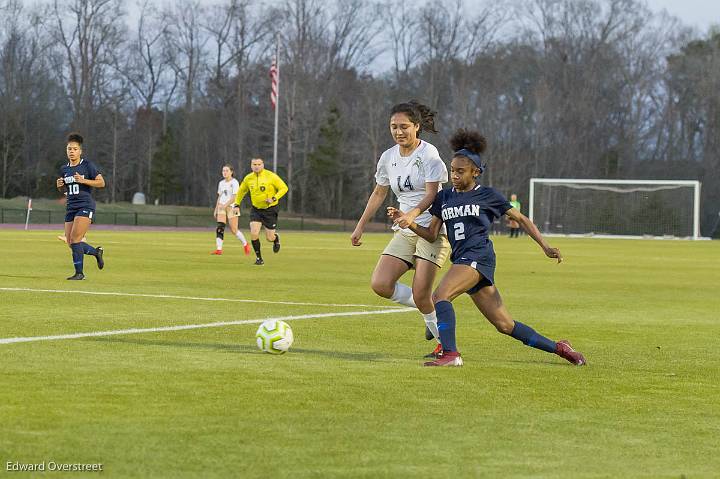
left=0, top=0, right=720, bottom=234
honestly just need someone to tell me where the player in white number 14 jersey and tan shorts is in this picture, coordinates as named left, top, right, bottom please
left=350, top=101, right=450, bottom=356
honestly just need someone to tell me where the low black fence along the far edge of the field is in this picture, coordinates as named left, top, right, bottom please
left=0, top=208, right=391, bottom=232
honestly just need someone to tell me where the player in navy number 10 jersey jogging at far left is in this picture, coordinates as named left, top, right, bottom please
left=56, top=133, right=105, bottom=280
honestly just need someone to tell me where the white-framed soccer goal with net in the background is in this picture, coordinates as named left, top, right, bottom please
left=528, top=178, right=700, bottom=239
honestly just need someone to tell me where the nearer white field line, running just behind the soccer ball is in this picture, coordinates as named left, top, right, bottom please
left=0, top=308, right=417, bottom=344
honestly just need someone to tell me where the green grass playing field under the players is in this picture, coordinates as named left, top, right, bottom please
left=0, top=230, right=720, bottom=478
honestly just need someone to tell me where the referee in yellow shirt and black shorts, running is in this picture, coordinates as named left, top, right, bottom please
left=233, top=158, right=287, bottom=265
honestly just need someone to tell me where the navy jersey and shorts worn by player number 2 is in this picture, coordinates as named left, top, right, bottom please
left=430, top=185, right=512, bottom=284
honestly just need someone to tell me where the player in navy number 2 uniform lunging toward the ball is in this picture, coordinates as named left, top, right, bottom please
left=388, top=130, right=586, bottom=366
